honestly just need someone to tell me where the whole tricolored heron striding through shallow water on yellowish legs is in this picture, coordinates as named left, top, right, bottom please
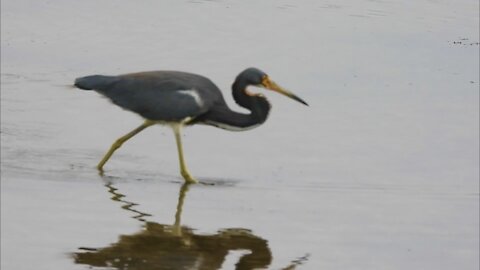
left=75, top=68, right=308, bottom=183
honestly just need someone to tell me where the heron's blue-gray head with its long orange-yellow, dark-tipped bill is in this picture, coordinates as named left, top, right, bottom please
left=237, top=67, right=308, bottom=106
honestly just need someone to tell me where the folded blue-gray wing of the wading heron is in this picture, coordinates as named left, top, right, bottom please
left=81, top=71, right=223, bottom=121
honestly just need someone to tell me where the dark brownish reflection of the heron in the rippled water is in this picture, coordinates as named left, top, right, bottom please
left=72, top=177, right=308, bottom=270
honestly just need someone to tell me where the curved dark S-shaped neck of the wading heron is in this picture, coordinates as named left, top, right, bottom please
left=202, top=80, right=270, bottom=131
